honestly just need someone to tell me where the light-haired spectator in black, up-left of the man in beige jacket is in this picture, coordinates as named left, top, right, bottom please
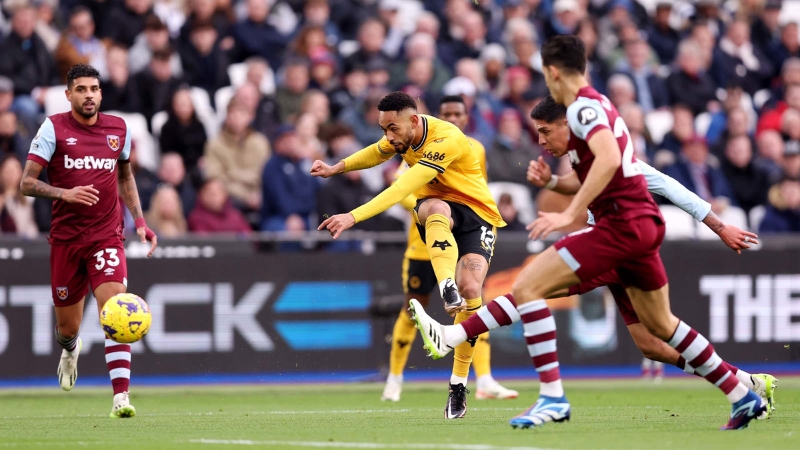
left=159, top=88, right=207, bottom=180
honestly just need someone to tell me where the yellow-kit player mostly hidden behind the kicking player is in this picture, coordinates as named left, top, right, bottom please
left=381, top=95, right=519, bottom=402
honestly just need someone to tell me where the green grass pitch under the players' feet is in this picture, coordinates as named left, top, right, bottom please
left=0, top=377, right=800, bottom=450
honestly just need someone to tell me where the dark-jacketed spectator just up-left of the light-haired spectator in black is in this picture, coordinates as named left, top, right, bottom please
left=134, top=48, right=181, bottom=123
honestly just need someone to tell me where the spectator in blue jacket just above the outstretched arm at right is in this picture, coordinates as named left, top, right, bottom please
left=664, top=135, right=735, bottom=214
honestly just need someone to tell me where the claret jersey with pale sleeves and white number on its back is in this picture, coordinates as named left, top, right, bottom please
left=567, top=86, right=663, bottom=221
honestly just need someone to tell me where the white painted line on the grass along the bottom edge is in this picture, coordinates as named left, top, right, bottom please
left=188, top=439, right=550, bottom=450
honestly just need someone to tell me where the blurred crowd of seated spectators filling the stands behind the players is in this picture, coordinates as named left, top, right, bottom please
left=0, top=0, right=800, bottom=237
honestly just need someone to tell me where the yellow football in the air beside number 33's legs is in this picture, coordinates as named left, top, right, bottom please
left=100, top=294, right=152, bottom=344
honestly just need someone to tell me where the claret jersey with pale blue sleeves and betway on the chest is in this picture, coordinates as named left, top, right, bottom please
left=28, top=112, right=131, bottom=244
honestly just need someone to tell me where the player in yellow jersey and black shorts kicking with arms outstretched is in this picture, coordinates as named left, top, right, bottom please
left=311, top=92, right=505, bottom=419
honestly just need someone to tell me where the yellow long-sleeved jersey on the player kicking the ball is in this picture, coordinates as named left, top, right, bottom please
left=344, top=114, right=506, bottom=232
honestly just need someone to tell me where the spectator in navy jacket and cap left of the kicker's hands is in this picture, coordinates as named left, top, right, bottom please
left=261, top=126, right=319, bottom=231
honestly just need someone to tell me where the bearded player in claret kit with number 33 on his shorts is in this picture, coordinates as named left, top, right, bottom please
left=21, top=64, right=157, bottom=417
